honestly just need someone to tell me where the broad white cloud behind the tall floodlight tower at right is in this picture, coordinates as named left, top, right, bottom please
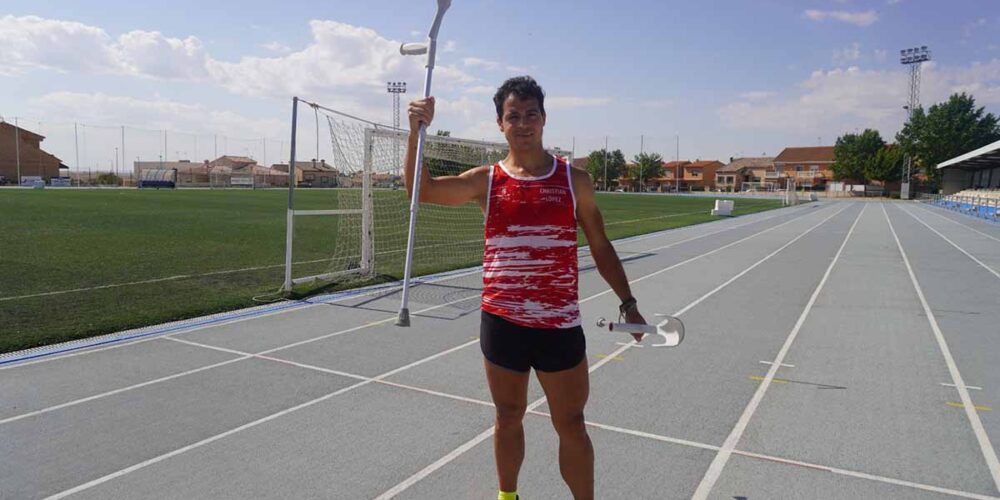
left=718, top=59, right=1000, bottom=137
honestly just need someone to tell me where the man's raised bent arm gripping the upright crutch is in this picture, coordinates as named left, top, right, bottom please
left=403, top=97, right=489, bottom=205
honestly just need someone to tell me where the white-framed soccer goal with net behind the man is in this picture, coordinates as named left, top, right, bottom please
left=283, top=98, right=572, bottom=291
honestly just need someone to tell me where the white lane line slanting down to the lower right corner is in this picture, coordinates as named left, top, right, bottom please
left=882, top=205, right=1000, bottom=491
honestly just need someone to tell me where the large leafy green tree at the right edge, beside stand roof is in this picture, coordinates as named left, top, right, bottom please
left=896, top=92, right=1000, bottom=180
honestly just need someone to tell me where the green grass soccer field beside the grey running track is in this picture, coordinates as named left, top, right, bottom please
left=0, top=189, right=780, bottom=352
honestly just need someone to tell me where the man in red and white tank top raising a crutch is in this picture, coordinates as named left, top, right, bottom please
left=405, top=76, right=646, bottom=500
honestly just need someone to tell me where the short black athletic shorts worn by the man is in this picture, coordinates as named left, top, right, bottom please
left=479, top=311, right=587, bottom=372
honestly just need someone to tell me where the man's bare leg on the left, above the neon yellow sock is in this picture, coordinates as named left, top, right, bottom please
left=483, top=360, right=530, bottom=491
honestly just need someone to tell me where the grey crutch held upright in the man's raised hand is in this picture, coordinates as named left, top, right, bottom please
left=396, top=0, right=451, bottom=326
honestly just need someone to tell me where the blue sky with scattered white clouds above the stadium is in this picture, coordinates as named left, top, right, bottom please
left=0, top=0, right=1000, bottom=171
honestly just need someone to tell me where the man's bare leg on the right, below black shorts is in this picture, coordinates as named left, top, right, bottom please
left=536, top=358, right=594, bottom=500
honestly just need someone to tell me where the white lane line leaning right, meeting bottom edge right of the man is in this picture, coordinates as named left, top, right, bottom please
left=692, top=203, right=868, bottom=500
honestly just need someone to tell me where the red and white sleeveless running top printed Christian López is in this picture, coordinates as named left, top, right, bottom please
left=482, top=157, right=580, bottom=328
